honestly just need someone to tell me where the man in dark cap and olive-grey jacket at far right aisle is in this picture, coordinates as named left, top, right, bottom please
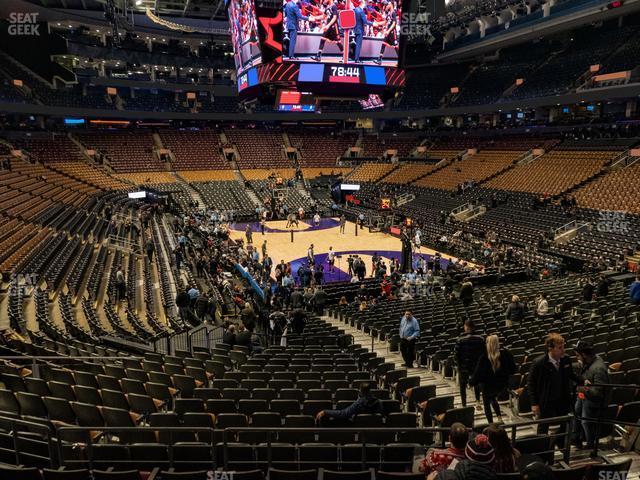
left=573, top=342, right=610, bottom=449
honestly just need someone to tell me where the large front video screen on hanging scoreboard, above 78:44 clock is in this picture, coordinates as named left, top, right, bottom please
left=282, top=0, right=401, bottom=67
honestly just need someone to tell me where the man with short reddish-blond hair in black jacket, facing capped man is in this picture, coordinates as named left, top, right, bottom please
left=529, top=333, right=578, bottom=445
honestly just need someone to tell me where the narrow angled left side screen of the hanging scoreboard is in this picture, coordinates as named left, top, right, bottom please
left=229, top=0, right=262, bottom=75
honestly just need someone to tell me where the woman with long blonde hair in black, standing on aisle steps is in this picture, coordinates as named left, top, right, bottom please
left=469, top=335, right=516, bottom=423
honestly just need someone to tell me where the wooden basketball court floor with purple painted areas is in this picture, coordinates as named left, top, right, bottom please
left=230, top=218, right=474, bottom=283
